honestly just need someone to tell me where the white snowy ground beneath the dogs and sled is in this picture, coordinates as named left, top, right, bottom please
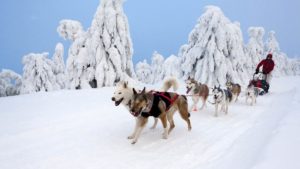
left=0, top=77, right=300, bottom=169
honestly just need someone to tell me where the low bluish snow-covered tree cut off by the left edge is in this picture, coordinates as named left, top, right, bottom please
left=0, top=69, right=22, bottom=97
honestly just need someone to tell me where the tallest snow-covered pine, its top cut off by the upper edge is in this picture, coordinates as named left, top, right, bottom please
left=91, top=0, right=135, bottom=86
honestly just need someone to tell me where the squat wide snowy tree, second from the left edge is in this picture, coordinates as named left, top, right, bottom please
left=21, top=53, right=59, bottom=93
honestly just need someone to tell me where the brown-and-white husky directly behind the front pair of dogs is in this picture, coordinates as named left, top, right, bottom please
left=185, top=77, right=209, bottom=111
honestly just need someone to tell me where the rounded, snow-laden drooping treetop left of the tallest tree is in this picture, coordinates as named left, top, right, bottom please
left=57, top=19, right=84, bottom=41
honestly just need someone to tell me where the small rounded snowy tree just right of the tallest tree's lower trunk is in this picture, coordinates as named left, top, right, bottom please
left=135, top=60, right=153, bottom=84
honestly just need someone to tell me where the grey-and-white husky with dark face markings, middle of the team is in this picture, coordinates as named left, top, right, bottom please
left=212, top=86, right=232, bottom=117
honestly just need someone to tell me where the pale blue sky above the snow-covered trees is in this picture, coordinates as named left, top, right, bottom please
left=0, top=0, right=300, bottom=73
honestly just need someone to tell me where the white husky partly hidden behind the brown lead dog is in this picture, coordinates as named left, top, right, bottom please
left=111, top=78, right=178, bottom=129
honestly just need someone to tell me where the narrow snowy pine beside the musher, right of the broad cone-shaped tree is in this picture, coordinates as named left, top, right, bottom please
left=247, top=27, right=265, bottom=73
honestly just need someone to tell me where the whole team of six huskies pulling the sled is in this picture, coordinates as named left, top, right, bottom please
left=112, top=77, right=259, bottom=144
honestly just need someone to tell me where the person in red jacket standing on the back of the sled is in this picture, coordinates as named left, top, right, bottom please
left=255, top=53, right=275, bottom=84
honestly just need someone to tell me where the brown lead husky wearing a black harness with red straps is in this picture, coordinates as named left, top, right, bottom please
left=128, top=88, right=192, bottom=144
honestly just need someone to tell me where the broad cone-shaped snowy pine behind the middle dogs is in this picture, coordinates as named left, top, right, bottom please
left=179, top=6, right=249, bottom=85
